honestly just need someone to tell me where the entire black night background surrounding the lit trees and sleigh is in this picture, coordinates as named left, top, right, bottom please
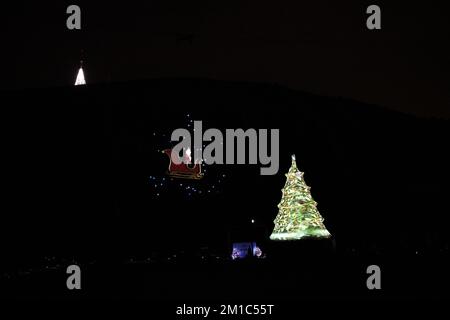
left=1, top=2, right=450, bottom=303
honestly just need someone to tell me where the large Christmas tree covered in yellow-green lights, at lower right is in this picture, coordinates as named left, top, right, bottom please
left=270, top=155, right=331, bottom=240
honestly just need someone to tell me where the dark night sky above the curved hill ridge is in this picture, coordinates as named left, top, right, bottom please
left=0, top=0, right=450, bottom=118
